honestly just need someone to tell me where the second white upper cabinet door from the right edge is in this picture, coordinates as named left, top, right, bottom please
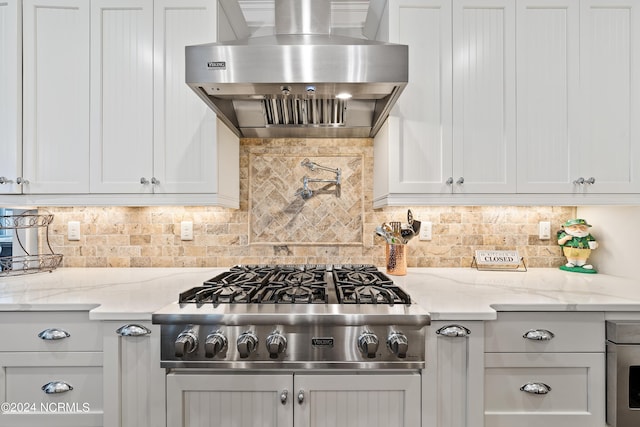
left=516, top=0, right=580, bottom=193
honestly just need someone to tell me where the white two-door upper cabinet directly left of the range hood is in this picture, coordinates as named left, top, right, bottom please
left=91, top=0, right=239, bottom=207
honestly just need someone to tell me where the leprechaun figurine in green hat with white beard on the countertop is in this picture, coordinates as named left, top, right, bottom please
left=558, top=219, right=598, bottom=273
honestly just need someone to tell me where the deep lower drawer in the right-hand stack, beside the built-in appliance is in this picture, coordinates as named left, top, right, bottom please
left=484, top=353, right=605, bottom=427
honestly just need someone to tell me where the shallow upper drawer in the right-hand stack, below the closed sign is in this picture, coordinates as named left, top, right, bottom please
left=485, top=312, right=605, bottom=353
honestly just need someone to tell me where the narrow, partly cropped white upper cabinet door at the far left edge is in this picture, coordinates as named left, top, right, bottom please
left=0, top=0, right=22, bottom=194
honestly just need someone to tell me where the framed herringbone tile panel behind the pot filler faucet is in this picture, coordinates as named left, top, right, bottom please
left=249, top=154, right=364, bottom=245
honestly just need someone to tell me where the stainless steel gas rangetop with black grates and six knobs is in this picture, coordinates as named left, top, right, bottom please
left=152, top=265, right=430, bottom=369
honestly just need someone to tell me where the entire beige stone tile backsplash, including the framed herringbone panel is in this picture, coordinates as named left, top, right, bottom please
left=42, top=138, right=576, bottom=267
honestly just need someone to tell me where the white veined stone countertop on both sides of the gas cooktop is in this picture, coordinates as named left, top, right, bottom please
left=0, top=268, right=640, bottom=320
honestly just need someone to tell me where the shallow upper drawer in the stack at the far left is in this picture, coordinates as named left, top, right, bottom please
left=0, top=311, right=102, bottom=352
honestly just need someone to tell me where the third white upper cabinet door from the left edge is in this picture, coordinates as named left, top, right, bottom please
left=91, top=0, right=154, bottom=193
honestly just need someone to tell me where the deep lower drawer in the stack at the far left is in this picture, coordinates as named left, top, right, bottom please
left=0, top=352, right=103, bottom=427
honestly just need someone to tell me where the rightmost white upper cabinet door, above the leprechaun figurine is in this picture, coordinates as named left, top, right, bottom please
left=574, top=0, right=640, bottom=193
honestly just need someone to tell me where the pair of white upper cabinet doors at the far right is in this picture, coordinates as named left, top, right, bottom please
left=516, top=0, right=640, bottom=195
